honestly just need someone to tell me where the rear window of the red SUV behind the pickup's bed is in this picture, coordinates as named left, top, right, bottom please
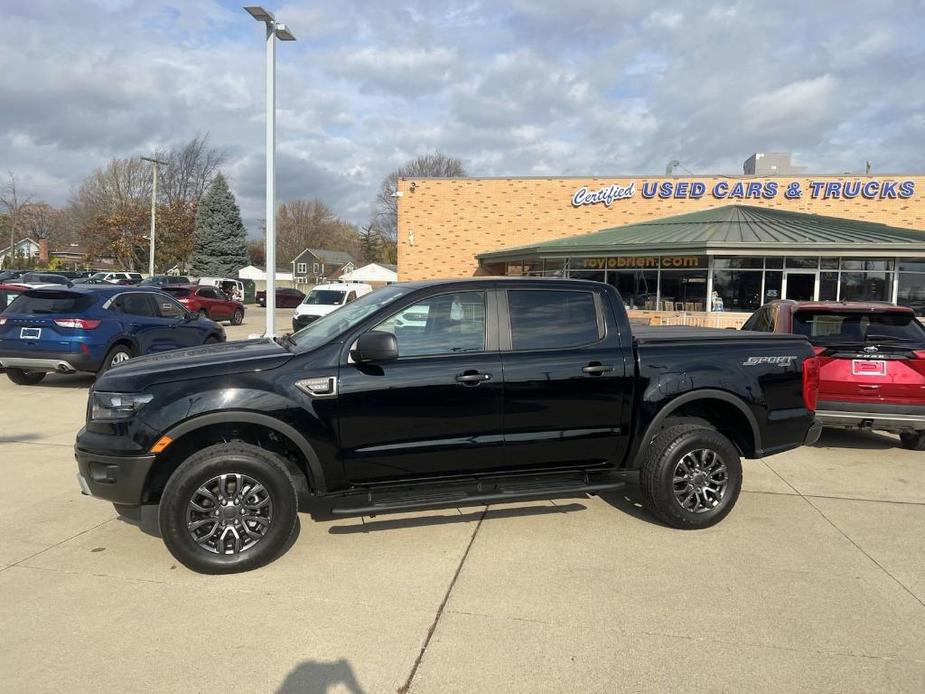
left=793, top=311, right=925, bottom=345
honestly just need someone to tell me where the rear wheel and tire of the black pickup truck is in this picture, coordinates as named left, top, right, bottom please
left=639, top=424, right=742, bottom=530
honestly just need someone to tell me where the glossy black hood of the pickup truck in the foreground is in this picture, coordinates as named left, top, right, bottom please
left=94, top=338, right=292, bottom=392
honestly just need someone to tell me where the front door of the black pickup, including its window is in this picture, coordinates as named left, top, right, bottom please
left=337, top=290, right=503, bottom=482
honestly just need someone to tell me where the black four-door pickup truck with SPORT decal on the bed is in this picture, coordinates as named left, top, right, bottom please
left=76, top=278, right=819, bottom=573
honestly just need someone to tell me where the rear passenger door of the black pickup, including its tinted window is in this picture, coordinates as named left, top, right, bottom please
left=499, top=288, right=633, bottom=468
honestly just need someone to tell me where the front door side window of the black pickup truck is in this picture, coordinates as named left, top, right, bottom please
left=374, top=292, right=486, bottom=357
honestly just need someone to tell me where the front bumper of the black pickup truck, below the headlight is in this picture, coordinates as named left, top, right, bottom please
left=74, top=447, right=155, bottom=506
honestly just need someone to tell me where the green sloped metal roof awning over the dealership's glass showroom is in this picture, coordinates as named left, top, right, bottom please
left=477, top=205, right=925, bottom=262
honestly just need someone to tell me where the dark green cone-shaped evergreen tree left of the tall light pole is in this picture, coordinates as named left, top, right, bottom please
left=190, top=174, right=250, bottom=277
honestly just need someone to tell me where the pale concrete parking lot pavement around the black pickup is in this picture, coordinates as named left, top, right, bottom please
left=0, top=310, right=925, bottom=693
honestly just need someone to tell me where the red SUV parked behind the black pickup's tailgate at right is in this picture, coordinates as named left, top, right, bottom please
left=742, top=301, right=925, bottom=451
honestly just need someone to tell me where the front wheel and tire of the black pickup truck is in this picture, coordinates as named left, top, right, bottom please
left=158, top=441, right=298, bottom=574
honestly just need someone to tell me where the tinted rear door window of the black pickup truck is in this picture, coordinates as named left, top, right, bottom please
left=507, top=289, right=602, bottom=350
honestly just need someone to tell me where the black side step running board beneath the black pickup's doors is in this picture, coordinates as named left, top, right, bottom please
left=331, top=480, right=626, bottom=516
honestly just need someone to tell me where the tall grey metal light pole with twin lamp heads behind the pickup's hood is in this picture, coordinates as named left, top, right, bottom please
left=244, top=5, right=295, bottom=337
